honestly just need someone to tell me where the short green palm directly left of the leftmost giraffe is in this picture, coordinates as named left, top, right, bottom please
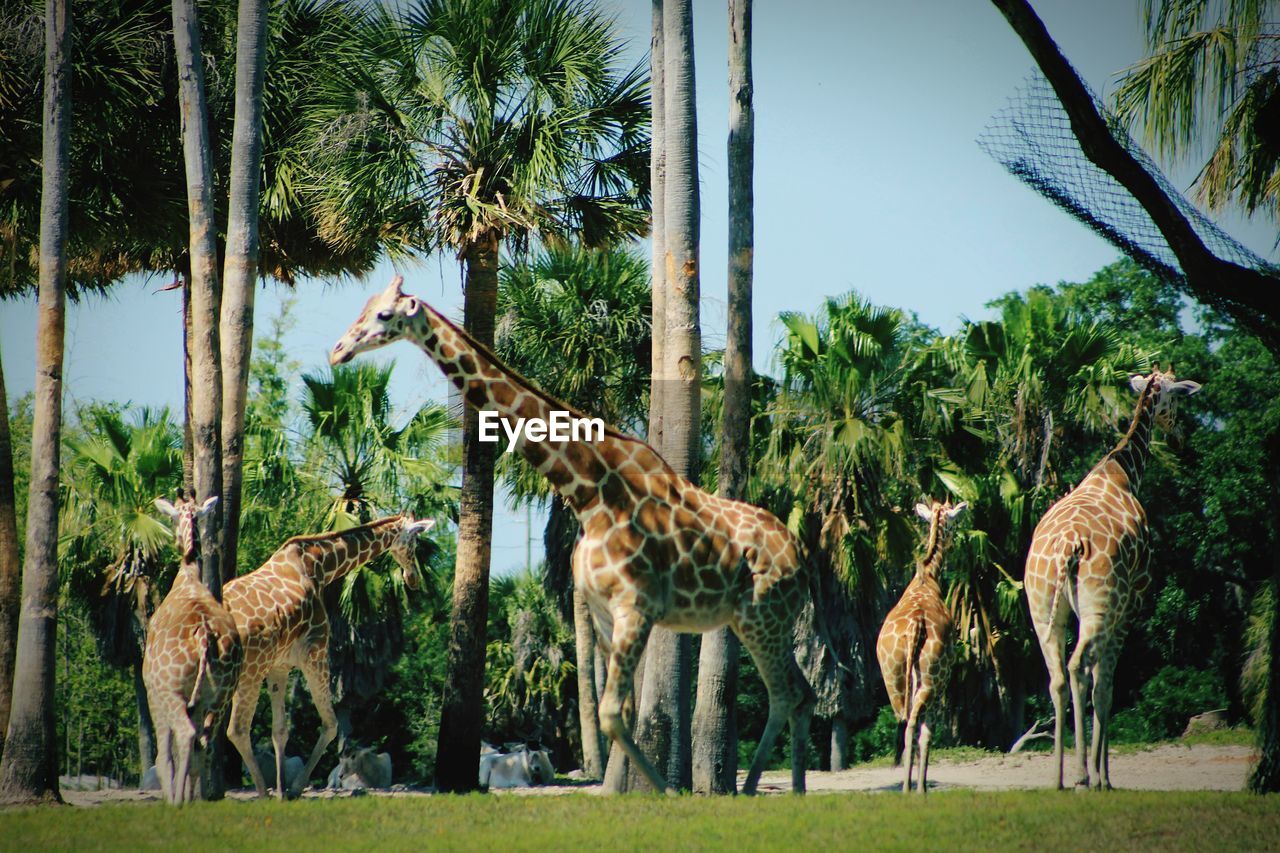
left=61, top=407, right=182, bottom=771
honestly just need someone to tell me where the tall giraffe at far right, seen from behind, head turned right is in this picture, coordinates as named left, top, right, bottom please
left=1023, top=368, right=1201, bottom=789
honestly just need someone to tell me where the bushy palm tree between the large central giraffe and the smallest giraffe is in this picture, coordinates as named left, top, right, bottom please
left=754, top=293, right=924, bottom=763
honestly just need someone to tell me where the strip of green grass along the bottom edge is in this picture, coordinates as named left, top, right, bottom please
left=0, top=790, right=1280, bottom=853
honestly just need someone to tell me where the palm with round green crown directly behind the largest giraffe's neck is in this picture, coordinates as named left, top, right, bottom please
left=497, top=240, right=652, bottom=779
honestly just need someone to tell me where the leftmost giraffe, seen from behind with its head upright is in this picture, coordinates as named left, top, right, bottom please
left=142, top=496, right=243, bottom=806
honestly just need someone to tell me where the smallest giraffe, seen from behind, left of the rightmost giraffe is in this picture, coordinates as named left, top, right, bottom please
left=876, top=501, right=969, bottom=794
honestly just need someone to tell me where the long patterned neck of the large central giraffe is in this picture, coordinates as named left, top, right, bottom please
left=406, top=301, right=650, bottom=512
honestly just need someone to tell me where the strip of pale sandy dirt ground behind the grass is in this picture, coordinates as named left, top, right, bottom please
left=63, top=743, right=1254, bottom=806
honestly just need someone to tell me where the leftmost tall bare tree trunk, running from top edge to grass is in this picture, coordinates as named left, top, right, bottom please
left=0, top=0, right=72, bottom=803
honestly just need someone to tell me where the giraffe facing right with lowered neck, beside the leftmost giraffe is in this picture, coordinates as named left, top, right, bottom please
left=223, top=515, right=435, bottom=799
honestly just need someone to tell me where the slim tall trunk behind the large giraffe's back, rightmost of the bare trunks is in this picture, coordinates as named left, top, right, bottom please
left=694, top=0, right=755, bottom=794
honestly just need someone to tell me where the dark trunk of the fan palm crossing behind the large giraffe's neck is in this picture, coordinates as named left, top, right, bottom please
left=435, top=233, right=498, bottom=792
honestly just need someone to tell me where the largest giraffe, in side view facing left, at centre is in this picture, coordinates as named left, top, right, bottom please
left=329, top=277, right=815, bottom=794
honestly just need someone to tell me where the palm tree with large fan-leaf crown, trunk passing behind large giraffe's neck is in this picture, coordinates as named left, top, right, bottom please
left=316, top=0, right=648, bottom=790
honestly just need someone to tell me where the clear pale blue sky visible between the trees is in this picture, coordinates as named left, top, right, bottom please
left=0, top=0, right=1275, bottom=573
